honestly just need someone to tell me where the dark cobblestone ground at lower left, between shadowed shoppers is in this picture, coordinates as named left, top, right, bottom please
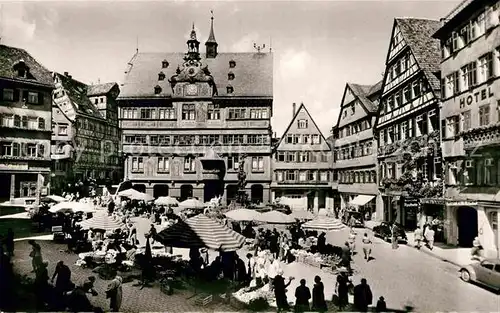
left=14, top=241, right=235, bottom=312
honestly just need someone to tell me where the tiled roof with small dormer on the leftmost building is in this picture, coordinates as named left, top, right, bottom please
left=0, top=45, right=54, bottom=88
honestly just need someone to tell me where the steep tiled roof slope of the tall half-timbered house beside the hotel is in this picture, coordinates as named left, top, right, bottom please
left=394, top=18, right=441, bottom=91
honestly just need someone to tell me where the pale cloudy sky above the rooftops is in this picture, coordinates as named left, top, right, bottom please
left=0, top=0, right=461, bottom=137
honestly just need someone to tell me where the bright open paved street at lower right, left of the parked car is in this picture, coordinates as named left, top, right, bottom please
left=329, top=229, right=500, bottom=312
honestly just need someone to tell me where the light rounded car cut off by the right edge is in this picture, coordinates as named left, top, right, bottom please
left=460, top=259, right=500, bottom=291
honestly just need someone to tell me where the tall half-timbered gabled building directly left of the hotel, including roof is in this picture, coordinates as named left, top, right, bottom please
left=375, top=18, right=442, bottom=228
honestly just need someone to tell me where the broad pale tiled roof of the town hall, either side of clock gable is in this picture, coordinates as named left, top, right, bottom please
left=118, top=53, right=273, bottom=99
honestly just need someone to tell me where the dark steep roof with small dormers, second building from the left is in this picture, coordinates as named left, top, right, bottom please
left=54, top=73, right=103, bottom=119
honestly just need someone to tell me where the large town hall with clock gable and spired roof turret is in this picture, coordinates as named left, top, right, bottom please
left=118, top=17, right=273, bottom=203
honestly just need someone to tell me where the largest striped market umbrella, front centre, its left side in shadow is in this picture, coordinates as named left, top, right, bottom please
left=157, top=214, right=245, bottom=251
